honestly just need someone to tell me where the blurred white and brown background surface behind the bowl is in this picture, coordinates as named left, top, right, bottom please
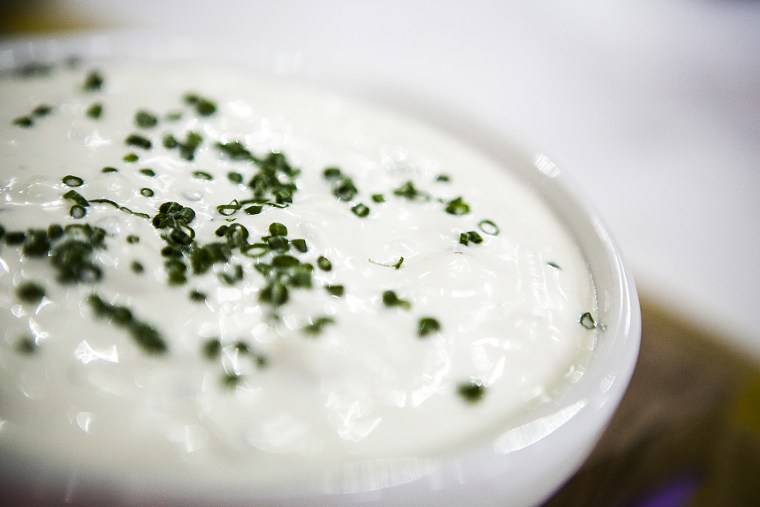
left=0, top=0, right=760, bottom=505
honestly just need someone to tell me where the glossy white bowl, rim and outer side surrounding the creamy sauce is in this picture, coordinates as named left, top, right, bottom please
left=0, top=32, right=641, bottom=505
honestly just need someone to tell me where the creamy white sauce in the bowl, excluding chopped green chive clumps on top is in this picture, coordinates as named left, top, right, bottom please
left=0, top=63, right=596, bottom=492
